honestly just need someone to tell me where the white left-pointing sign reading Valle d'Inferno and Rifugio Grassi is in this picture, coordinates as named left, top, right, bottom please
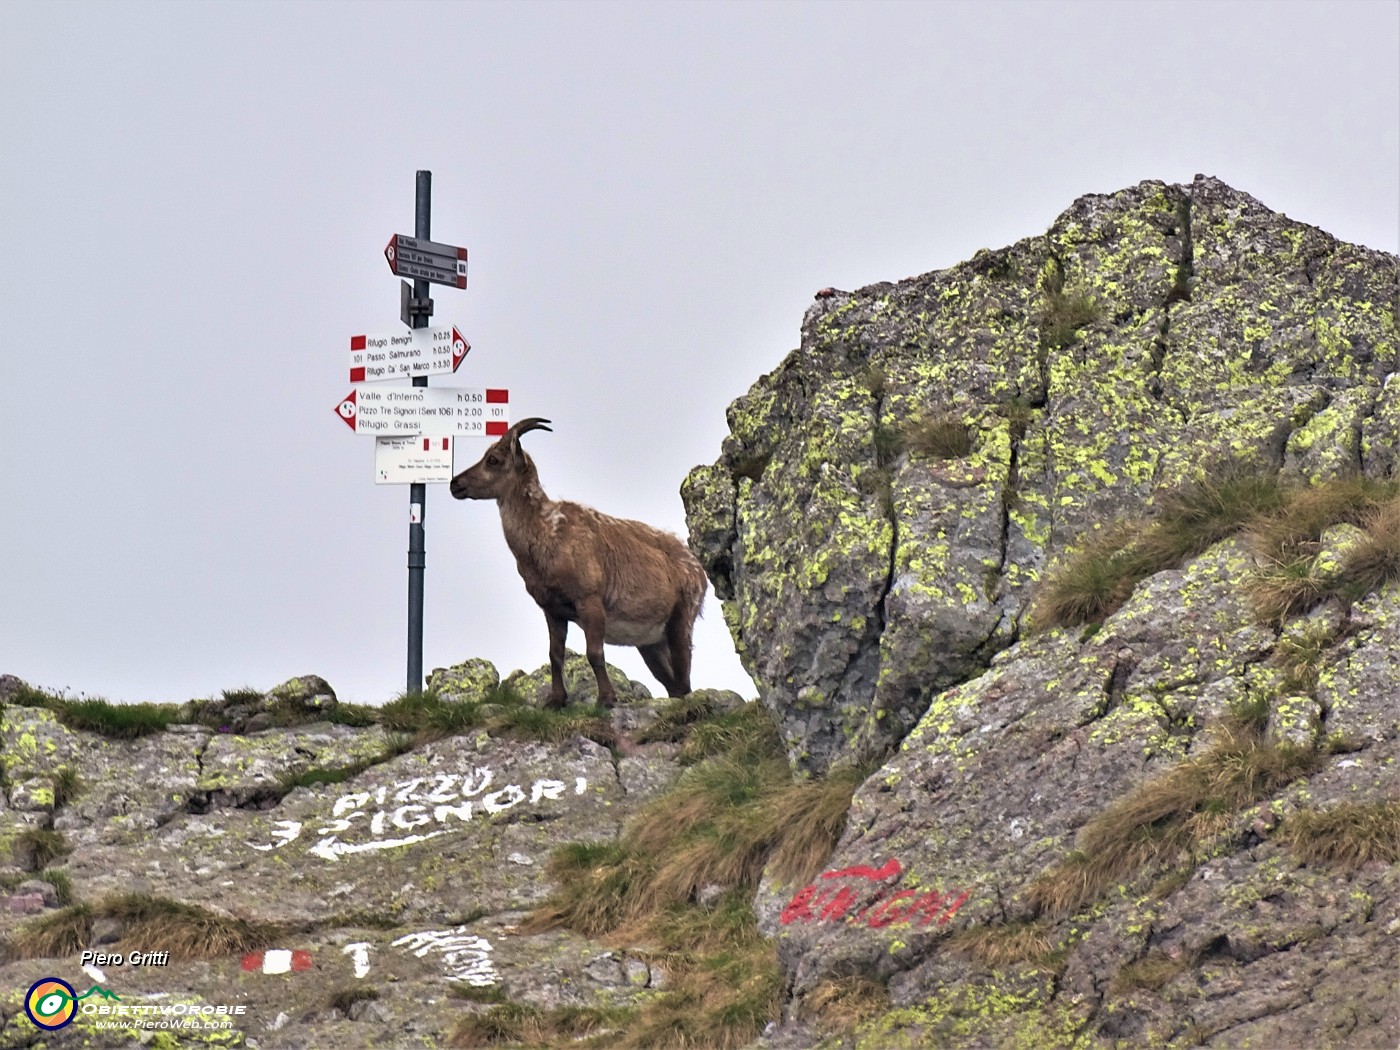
left=336, top=386, right=510, bottom=437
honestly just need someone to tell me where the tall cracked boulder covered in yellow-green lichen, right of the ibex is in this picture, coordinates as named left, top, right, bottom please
left=682, top=176, right=1400, bottom=771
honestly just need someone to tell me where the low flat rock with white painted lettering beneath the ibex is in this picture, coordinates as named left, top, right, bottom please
left=0, top=669, right=697, bottom=1050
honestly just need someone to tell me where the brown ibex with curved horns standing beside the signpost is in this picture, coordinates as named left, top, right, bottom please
left=451, top=417, right=706, bottom=707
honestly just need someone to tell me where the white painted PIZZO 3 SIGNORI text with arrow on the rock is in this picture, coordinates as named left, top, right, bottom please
left=248, top=766, right=588, bottom=861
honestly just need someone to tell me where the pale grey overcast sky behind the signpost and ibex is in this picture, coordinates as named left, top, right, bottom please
left=0, top=0, right=1400, bottom=703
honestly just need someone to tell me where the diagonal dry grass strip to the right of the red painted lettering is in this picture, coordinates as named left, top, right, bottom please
left=1028, top=722, right=1320, bottom=917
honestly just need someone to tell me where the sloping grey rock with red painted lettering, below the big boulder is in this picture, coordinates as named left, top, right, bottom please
left=756, top=539, right=1400, bottom=1050
